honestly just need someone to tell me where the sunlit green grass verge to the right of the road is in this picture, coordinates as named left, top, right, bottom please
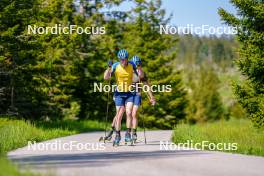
left=173, top=119, right=264, bottom=156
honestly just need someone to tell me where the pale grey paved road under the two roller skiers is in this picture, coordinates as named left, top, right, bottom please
left=8, top=131, right=264, bottom=176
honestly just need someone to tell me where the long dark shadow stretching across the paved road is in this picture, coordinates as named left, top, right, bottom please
left=10, top=150, right=209, bottom=168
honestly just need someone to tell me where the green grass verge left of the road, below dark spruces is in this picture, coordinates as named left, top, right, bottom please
left=0, top=117, right=107, bottom=176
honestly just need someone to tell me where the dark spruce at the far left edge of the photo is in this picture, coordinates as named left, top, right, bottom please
left=0, top=0, right=46, bottom=118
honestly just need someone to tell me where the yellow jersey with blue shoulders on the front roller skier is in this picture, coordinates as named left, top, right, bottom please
left=112, top=61, right=137, bottom=92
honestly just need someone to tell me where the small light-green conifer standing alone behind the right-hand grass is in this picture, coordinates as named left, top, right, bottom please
left=186, top=62, right=224, bottom=123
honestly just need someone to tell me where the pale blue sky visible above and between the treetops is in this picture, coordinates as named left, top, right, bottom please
left=105, top=0, right=236, bottom=27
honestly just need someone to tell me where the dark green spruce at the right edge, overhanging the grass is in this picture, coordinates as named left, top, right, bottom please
left=219, top=0, right=264, bottom=127
